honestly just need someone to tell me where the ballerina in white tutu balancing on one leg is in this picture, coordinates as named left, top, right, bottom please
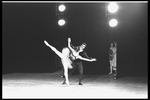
left=44, top=40, right=96, bottom=86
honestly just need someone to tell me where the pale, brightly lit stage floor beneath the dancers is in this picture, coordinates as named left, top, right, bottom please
left=2, top=71, right=148, bottom=99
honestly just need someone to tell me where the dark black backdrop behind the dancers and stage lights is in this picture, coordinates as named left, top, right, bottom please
left=2, top=3, right=148, bottom=76
